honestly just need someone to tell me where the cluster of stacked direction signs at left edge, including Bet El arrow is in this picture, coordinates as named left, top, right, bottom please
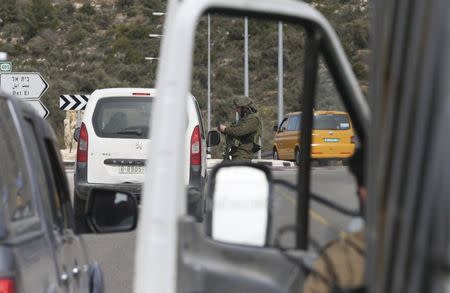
left=0, top=72, right=50, bottom=119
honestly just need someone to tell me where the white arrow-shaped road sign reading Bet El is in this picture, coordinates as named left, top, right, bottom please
left=0, top=72, right=48, bottom=100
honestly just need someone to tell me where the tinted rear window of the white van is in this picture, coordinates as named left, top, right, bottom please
left=92, top=97, right=152, bottom=139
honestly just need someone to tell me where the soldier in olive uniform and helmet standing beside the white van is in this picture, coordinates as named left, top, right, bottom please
left=218, top=96, right=262, bottom=161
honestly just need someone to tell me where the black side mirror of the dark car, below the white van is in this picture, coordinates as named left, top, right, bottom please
left=87, top=189, right=138, bottom=233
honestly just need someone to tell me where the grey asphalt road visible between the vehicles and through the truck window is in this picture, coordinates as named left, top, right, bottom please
left=67, top=167, right=358, bottom=293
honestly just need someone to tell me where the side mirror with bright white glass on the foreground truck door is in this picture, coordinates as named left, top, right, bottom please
left=206, top=162, right=272, bottom=247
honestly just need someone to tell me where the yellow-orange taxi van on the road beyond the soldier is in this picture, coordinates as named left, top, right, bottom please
left=272, top=111, right=356, bottom=164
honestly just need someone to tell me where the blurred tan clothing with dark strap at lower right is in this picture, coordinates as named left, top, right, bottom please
left=302, top=232, right=365, bottom=293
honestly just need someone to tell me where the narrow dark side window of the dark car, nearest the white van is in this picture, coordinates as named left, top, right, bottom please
left=24, top=119, right=63, bottom=231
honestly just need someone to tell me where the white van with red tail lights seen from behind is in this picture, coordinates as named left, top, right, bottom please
left=74, top=88, right=206, bottom=230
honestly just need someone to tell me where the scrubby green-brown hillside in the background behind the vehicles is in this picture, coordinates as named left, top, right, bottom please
left=0, top=0, right=369, bottom=150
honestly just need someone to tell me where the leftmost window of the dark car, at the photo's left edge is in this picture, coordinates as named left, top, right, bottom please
left=0, top=99, right=36, bottom=222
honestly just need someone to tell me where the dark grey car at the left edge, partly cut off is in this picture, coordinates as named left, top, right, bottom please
left=0, top=93, right=103, bottom=293
